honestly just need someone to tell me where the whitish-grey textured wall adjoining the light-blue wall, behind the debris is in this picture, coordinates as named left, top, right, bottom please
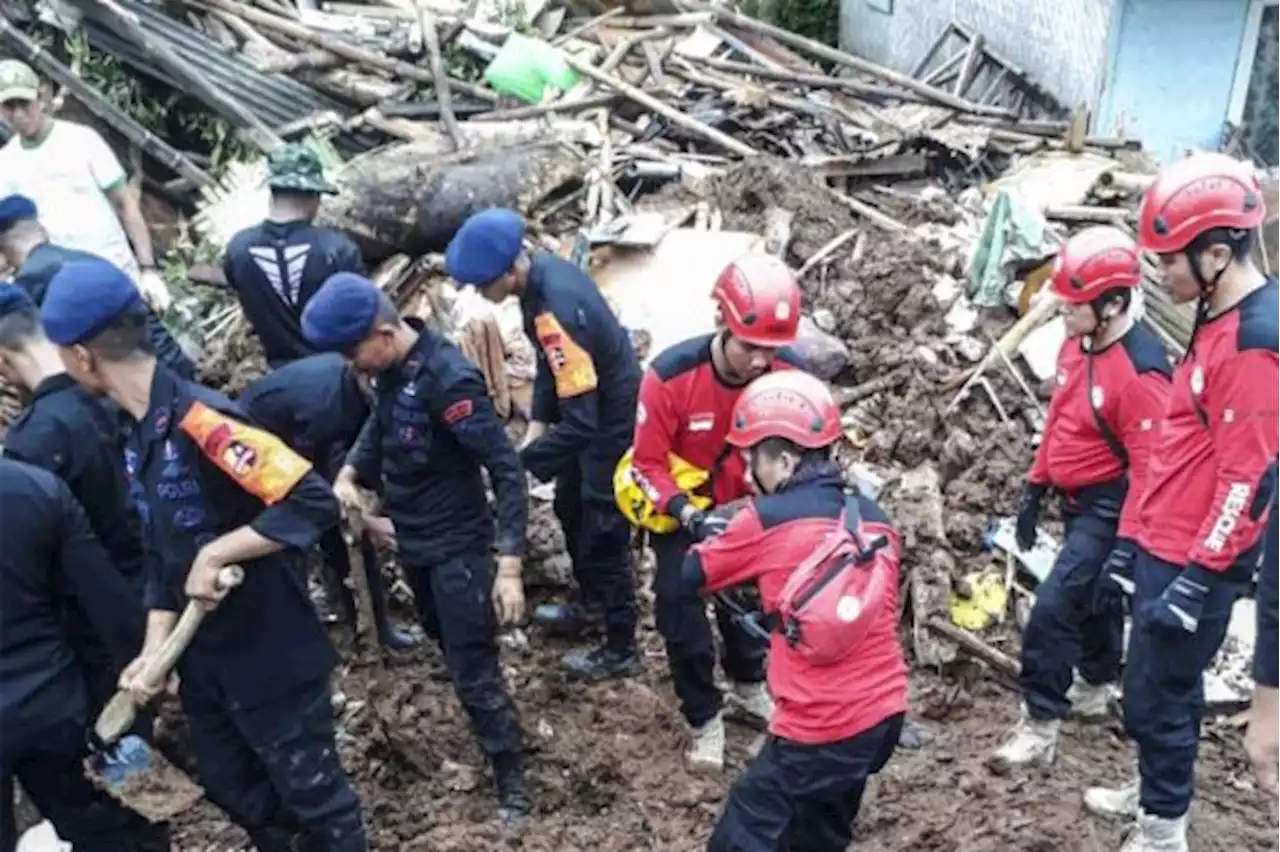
left=840, top=0, right=1116, bottom=107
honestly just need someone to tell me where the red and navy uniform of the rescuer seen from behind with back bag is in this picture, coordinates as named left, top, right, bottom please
left=684, top=462, right=908, bottom=852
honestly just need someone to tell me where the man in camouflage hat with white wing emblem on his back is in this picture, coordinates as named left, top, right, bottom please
left=223, top=143, right=365, bottom=370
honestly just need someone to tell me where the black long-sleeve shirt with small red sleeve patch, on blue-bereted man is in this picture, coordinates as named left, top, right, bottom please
left=347, top=320, right=529, bottom=565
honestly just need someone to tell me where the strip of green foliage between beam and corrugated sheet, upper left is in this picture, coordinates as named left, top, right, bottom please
left=63, top=32, right=256, bottom=175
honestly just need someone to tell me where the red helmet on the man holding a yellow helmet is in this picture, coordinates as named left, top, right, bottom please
left=712, top=255, right=800, bottom=347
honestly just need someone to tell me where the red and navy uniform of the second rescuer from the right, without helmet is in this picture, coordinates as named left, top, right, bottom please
left=1019, top=325, right=1170, bottom=720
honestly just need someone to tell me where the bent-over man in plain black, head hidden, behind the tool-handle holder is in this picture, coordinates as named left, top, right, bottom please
left=238, top=353, right=417, bottom=651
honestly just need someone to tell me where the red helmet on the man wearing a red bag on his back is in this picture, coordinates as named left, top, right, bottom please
left=726, top=370, right=841, bottom=449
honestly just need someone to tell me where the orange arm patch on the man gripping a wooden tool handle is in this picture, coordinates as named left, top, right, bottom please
left=178, top=402, right=311, bottom=505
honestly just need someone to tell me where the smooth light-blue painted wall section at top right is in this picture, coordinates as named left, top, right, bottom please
left=1093, top=0, right=1249, bottom=162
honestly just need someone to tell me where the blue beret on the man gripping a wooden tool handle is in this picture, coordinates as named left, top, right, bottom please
left=40, top=258, right=145, bottom=347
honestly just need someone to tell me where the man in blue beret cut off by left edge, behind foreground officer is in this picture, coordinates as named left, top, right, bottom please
left=0, top=284, right=145, bottom=709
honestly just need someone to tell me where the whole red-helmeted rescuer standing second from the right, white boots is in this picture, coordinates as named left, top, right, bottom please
left=992, top=226, right=1171, bottom=769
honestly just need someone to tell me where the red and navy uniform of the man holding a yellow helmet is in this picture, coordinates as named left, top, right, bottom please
left=634, top=334, right=799, bottom=728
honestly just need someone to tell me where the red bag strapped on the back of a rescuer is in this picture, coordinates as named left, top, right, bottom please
left=773, top=495, right=897, bottom=665
